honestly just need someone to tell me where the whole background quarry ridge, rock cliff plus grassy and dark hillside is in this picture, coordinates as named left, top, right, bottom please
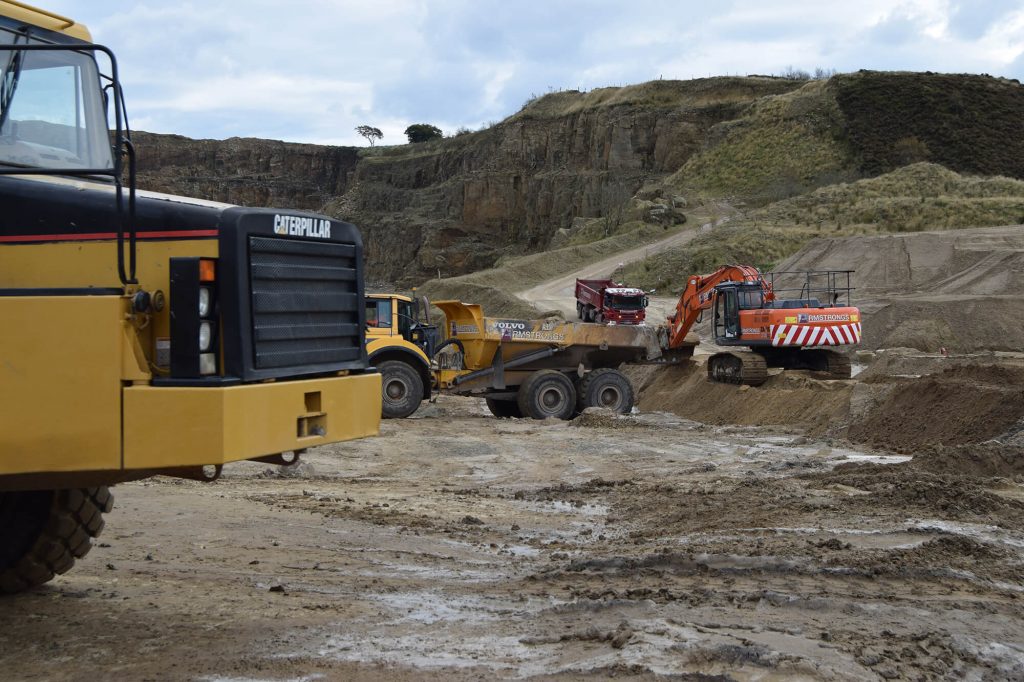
left=130, top=72, right=1024, bottom=287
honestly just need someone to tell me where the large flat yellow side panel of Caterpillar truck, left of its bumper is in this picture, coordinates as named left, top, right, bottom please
left=0, top=296, right=125, bottom=474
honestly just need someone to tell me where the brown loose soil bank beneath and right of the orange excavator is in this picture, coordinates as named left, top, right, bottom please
left=631, top=350, right=1024, bottom=456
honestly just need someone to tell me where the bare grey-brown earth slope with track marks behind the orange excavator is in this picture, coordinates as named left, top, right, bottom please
left=776, top=226, right=1024, bottom=352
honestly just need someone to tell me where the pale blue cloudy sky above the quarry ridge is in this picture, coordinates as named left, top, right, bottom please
left=34, top=0, right=1024, bottom=144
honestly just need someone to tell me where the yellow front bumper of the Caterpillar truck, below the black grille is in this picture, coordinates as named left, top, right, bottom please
left=124, top=374, right=381, bottom=469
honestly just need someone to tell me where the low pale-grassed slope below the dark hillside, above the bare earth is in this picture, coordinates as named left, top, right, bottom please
left=616, top=163, right=1024, bottom=291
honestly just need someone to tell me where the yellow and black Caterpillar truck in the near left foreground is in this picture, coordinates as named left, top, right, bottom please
left=0, top=1, right=381, bottom=592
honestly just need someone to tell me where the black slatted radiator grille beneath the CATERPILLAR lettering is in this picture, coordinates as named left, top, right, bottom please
left=249, top=237, right=362, bottom=370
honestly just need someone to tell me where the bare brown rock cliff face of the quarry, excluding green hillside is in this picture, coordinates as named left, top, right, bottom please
left=135, top=78, right=800, bottom=283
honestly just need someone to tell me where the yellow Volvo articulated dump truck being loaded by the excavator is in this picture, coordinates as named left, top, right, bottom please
left=367, top=294, right=684, bottom=419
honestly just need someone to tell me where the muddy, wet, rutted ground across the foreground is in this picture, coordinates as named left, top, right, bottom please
left=0, top=397, right=1024, bottom=680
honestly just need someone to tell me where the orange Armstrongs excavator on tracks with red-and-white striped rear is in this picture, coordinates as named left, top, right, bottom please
left=668, top=265, right=860, bottom=386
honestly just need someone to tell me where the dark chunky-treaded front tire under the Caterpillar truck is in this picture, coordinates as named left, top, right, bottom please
left=0, top=487, right=114, bottom=594
